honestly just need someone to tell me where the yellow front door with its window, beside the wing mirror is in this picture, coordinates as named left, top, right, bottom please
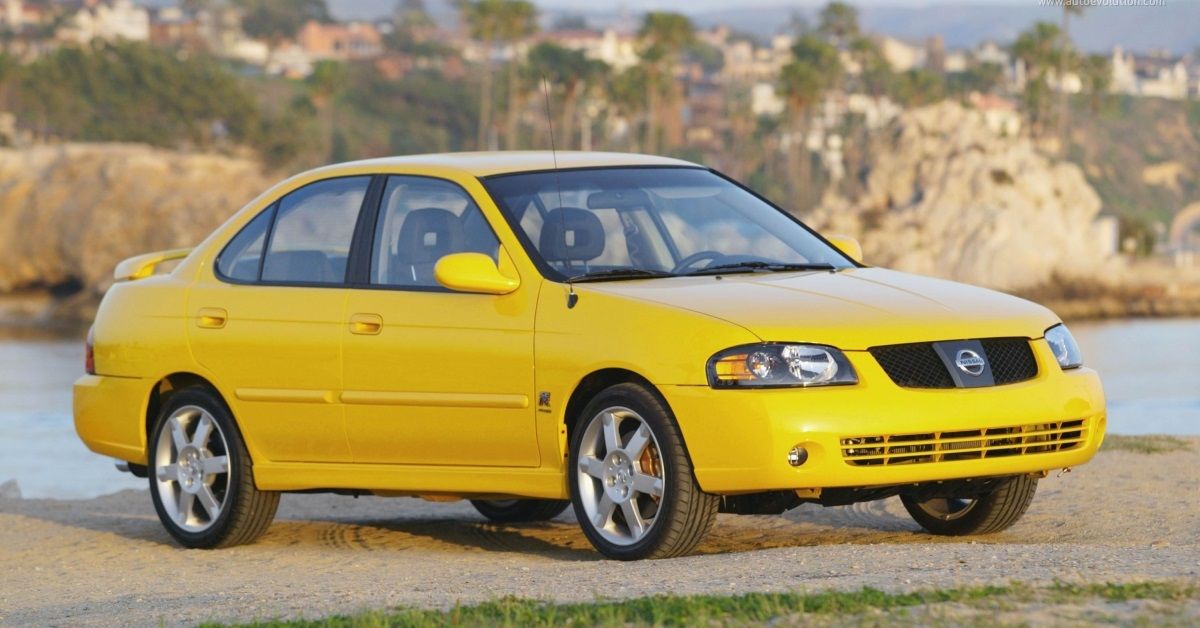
left=341, top=177, right=540, bottom=467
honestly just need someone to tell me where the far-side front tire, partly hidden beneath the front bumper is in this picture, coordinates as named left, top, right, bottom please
left=900, top=476, right=1038, bottom=537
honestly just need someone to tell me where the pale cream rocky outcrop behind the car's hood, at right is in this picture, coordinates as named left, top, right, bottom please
left=806, top=102, right=1115, bottom=291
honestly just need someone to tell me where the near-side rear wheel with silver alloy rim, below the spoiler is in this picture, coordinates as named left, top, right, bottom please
left=149, top=388, right=280, bottom=549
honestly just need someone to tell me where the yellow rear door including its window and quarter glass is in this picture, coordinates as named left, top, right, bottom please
left=188, top=177, right=372, bottom=462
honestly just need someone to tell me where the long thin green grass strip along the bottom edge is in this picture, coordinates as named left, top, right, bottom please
left=220, top=581, right=1200, bottom=628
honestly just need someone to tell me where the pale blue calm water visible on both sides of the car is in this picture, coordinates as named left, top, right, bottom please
left=0, top=319, right=1200, bottom=498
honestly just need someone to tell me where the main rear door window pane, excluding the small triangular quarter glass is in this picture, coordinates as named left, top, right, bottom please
left=263, top=177, right=371, bottom=283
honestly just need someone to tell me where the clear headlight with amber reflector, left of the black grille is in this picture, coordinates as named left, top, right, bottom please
left=708, top=342, right=858, bottom=388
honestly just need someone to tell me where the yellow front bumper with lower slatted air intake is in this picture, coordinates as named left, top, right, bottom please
left=659, top=340, right=1106, bottom=495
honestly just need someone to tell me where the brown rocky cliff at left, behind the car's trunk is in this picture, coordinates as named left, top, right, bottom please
left=0, top=144, right=269, bottom=303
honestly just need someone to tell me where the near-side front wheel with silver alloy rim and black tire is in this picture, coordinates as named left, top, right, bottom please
left=568, top=383, right=720, bottom=561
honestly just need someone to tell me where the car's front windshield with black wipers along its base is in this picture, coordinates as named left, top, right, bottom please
left=484, top=167, right=853, bottom=281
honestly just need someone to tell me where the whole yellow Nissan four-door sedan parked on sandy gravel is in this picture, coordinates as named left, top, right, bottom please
left=74, top=152, right=1105, bottom=560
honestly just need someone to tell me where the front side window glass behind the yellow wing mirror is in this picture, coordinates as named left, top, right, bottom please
left=371, top=177, right=499, bottom=288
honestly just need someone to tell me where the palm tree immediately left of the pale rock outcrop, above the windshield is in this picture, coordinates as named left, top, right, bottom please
left=780, top=35, right=841, bottom=208
